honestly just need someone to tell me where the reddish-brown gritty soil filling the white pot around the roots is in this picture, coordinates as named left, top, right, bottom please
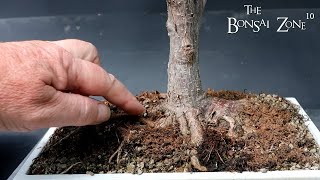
left=29, top=90, right=320, bottom=174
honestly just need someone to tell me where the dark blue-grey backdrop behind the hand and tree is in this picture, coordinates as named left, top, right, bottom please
left=0, top=0, right=320, bottom=179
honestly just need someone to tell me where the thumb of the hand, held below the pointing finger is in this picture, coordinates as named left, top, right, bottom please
left=43, top=91, right=111, bottom=127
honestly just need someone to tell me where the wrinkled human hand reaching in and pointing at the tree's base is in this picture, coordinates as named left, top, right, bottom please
left=0, top=40, right=144, bottom=131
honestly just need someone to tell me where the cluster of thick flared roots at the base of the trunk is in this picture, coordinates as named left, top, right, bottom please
left=152, top=98, right=246, bottom=147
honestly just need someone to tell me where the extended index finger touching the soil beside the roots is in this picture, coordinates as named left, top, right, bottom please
left=60, top=59, right=145, bottom=115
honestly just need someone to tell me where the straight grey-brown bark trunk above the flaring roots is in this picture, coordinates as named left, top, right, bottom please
left=167, top=0, right=205, bottom=107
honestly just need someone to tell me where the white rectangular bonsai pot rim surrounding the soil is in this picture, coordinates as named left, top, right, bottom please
left=10, top=98, right=320, bottom=180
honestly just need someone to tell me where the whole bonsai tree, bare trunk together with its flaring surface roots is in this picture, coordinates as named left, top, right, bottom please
left=155, top=0, right=242, bottom=171
